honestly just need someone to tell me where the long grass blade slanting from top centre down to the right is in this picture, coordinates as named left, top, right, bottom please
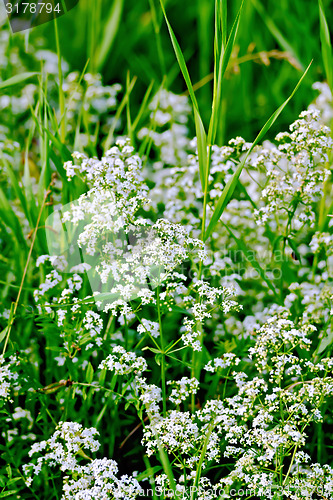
left=160, top=0, right=208, bottom=190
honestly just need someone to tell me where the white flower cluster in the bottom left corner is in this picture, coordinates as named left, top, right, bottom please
left=23, top=422, right=142, bottom=500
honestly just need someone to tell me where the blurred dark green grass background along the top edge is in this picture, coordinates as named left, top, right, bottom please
left=7, top=0, right=333, bottom=143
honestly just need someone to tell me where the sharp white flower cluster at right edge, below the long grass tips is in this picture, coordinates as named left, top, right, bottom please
left=249, top=109, right=333, bottom=231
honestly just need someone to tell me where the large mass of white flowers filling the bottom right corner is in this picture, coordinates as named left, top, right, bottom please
left=142, top=310, right=333, bottom=499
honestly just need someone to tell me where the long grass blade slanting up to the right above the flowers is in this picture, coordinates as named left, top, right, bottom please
left=204, top=61, right=312, bottom=241
